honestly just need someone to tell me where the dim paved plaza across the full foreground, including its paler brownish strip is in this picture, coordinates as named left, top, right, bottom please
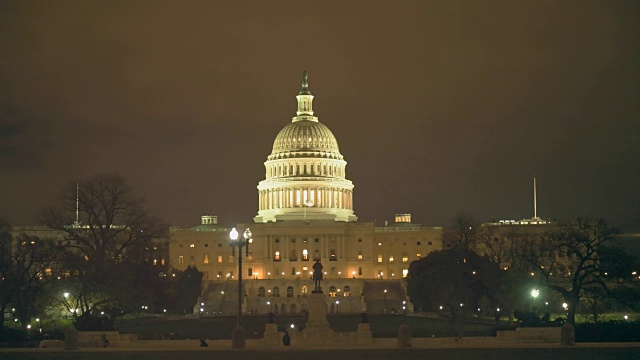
left=0, top=338, right=640, bottom=360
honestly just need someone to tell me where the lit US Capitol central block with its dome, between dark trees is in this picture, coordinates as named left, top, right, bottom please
left=169, top=71, right=442, bottom=315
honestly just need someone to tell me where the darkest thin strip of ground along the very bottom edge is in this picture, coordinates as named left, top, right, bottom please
left=0, top=345, right=640, bottom=360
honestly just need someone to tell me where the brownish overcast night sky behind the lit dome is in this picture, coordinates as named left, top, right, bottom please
left=0, top=0, right=640, bottom=231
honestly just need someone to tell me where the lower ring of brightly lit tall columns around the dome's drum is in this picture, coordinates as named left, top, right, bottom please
left=259, top=187, right=353, bottom=210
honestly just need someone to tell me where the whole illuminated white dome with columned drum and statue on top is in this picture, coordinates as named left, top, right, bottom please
left=254, top=70, right=358, bottom=223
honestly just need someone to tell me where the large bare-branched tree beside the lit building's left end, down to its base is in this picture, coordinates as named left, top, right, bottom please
left=44, top=175, right=168, bottom=328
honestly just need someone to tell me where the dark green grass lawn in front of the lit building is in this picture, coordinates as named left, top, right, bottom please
left=118, top=314, right=494, bottom=339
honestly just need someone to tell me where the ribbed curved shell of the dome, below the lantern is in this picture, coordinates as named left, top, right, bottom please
left=272, top=120, right=340, bottom=155
